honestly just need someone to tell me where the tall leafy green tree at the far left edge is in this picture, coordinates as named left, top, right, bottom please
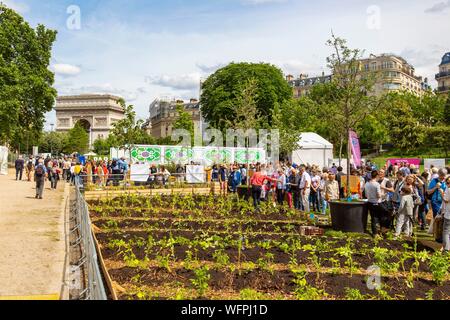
left=0, top=3, right=56, bottom=145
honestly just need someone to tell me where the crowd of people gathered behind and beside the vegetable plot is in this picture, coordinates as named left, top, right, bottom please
left=15, top=155, right=450, bottom=250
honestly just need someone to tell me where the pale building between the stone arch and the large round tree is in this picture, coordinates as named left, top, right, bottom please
left=144, top=99, right=202, bottom=139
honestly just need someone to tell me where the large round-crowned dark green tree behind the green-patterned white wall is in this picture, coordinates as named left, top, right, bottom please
left=201, top=63, right=292, bottom=130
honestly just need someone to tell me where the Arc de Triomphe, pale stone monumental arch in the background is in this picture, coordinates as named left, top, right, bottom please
left=55, top=94, right=125, bottom=147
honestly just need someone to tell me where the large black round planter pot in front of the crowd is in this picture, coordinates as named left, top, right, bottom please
left=330, top=201, right=369, bottom=233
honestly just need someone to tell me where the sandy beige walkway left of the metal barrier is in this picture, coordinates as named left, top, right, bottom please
left=0, top=171, right=69, bottom=298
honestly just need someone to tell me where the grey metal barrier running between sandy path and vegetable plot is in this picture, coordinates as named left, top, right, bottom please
left=71, top=175, right=108, bottom=300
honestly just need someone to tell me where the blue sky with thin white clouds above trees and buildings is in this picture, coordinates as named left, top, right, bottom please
left=3, top=0, right=450, bottom=127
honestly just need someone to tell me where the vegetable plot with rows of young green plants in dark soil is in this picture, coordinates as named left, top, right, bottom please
left=90, top=195, right=450, bottom=300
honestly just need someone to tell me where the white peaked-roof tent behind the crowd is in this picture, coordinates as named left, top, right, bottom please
left=292, top=132, right=333, bottom=168
